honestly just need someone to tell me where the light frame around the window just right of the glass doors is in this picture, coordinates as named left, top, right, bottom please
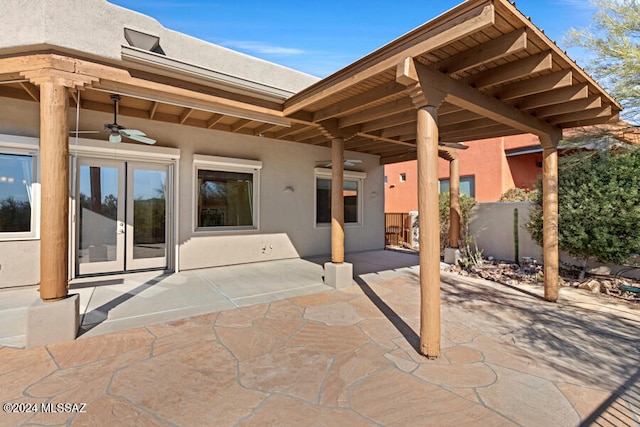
left=191, top=154, right=262, bottom=234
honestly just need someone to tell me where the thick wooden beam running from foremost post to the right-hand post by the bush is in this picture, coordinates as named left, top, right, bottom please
left=414, top=61, right=560, bottom=139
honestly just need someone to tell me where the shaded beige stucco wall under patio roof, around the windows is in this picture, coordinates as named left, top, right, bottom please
left=0, top=100, right=384, bottom=287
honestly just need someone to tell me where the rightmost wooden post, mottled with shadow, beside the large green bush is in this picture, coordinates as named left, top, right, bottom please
left=542, top=146, right=559, bottom=302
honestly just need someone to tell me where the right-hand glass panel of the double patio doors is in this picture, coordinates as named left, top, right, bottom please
left=126, top=163, right=169, bottom=270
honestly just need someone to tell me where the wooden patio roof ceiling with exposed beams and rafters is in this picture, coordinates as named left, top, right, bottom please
left=0, top=0, right=621, bottom=164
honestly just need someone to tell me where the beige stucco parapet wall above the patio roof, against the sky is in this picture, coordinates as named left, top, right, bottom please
left=0, top=0, right=318, bottom=93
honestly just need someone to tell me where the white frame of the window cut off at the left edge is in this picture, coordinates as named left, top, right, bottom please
left=0, top=139, right=40, bottom=242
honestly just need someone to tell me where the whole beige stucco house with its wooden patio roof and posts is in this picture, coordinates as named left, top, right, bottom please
left=0, top=0, right=621, bottom=357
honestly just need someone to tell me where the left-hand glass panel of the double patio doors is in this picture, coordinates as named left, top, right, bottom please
left=76, top=159, right=125, bottom=274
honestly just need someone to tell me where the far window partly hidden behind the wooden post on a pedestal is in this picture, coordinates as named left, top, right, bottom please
left=316, top=168, right=366, bottom=224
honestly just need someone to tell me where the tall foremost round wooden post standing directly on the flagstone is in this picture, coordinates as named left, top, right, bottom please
left=416, top=106, right=440, bottom=358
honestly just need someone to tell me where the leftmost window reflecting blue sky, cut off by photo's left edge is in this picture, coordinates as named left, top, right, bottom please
left=0, top=151, right=37, bottom=239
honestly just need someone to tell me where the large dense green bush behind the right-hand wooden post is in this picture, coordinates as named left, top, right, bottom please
left=529, top=151, right=640, bottom=264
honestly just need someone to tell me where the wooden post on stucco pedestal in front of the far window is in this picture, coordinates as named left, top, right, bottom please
left=331, top=138, right=344, bottom=264
